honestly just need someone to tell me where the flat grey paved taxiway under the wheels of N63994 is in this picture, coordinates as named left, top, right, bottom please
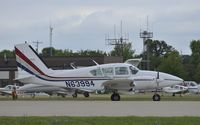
left=0, top=101, right=200, bottom=116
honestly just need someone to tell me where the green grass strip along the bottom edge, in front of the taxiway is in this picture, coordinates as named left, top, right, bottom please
left=0, top=116, right=200, bottom=125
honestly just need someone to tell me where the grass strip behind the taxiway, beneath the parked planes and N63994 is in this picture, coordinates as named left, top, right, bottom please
left=0, top=93, right=200, bottom=101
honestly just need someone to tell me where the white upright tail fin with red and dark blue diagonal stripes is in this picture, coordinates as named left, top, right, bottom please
left=15, top=43, right=49, bottom=75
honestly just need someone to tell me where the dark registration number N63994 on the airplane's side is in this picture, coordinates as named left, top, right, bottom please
left=65, top=80, right=94, bottom=87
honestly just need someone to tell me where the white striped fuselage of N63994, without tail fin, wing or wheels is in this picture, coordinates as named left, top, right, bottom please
left=20, top=63, right=183, bottom=92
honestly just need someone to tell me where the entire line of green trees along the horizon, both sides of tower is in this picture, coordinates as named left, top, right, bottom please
left=0, top=39, right=200, bottom=82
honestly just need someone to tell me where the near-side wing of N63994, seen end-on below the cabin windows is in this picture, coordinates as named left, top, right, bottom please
left=103, top=79, right=135, bottom=91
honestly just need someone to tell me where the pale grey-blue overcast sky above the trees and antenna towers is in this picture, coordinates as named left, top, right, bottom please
left=0, top=0, right=200, bottom=54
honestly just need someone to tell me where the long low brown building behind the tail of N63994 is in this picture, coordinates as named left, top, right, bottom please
left=0, top=56, right=123, bottom=87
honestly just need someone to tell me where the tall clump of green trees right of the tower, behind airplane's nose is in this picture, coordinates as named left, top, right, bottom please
left=139, top=39, right=200, bottom=82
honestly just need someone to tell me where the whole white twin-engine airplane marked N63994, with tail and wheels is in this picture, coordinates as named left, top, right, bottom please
left=15, top=43, right=183, bottom=101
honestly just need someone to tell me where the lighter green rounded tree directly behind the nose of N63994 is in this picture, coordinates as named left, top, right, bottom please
left=158, top=51, right=187, bottom=79
